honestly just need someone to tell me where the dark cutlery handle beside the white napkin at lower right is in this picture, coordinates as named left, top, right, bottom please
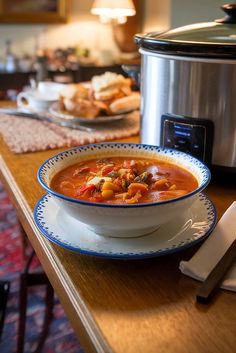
left=196, top=239, right=236, bottom=304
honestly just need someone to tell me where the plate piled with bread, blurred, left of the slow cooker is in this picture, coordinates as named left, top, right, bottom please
left=50, top=72, right=140, bottom=124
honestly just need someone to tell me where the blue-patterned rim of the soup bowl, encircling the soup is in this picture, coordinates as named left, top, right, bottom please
left=37, top=142, right=211, bottom=208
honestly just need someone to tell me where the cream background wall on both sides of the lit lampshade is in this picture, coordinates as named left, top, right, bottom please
left=0, top=0, right=232, bottom=59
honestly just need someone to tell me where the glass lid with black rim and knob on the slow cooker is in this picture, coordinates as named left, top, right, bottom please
left=135, top=4, right=236, bottom=59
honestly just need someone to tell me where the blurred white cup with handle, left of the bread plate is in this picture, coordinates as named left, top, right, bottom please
left=17, top=90, right=58, bottom=112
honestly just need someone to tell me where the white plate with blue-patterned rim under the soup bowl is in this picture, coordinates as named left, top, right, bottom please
left=34, top=193, right=216, bottom=259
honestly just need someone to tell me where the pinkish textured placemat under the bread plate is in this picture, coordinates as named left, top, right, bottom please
left=0, top=111, right=139, bottom=153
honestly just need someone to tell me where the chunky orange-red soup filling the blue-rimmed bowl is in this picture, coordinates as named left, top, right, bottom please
left=51, top=157, right=198, bottom=204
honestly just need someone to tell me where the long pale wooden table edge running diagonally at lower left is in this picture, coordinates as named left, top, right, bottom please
left=0, top=156, right=112, bottom=353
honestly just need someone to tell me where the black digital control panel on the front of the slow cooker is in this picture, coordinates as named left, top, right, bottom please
left=161, top=114, right=214, bottom=164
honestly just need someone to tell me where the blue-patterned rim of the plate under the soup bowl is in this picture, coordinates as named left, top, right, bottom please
left=34, top=193, right=217, bottom=260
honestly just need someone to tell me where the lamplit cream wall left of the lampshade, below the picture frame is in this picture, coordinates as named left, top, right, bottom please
left=0, top=0, right=119, bottom=60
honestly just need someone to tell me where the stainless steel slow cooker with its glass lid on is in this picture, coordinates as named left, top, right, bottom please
left=135, top=4, right=236, bottom=170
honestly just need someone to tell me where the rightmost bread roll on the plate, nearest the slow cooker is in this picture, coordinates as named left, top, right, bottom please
left=109, top=93, right=140, bottom=114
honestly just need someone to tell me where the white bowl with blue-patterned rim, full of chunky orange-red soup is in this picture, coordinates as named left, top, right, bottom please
left=37, top=143, right=210, bottom=238
